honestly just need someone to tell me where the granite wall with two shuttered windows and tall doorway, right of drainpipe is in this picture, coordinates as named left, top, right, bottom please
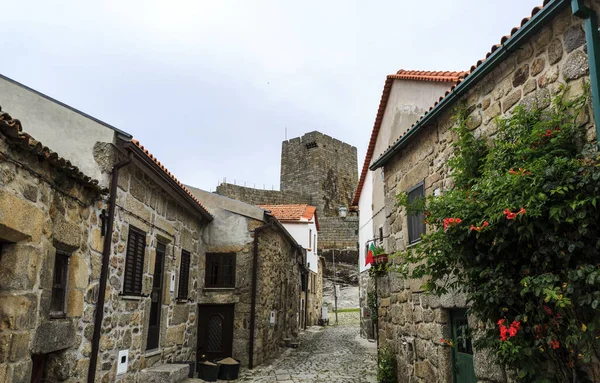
left=91, top=157, right=207, bottom=382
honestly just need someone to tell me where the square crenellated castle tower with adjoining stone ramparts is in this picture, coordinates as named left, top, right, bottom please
left=217, top=131, right=358, bottom=282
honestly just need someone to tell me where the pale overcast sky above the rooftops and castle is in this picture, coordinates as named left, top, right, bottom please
left=0, top=0, right=541, bottom=191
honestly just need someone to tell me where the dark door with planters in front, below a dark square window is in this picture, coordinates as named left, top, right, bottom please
left=196, top=305, right=234, bottom=360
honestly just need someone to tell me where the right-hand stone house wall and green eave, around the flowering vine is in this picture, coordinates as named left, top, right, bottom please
left=369, top=1, right=600, bottom=382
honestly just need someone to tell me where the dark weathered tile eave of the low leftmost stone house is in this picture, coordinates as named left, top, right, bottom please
left=0, top=108, right=107, bottom=193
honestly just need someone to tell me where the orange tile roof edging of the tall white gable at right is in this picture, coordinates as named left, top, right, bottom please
left=351, top=69, right=468, bottom=206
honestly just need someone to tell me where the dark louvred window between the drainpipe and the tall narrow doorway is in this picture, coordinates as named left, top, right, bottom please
left=123, top=226, right=146, bottom=295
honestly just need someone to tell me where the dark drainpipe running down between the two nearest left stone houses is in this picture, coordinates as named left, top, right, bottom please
left=88, top=155, right=131, bottom=383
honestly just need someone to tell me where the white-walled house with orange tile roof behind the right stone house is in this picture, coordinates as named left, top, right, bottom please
left=352, top=70, right=466, bottom=339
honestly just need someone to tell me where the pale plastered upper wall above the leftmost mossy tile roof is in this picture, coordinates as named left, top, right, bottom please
left=0, top=76, right=123, bottom=186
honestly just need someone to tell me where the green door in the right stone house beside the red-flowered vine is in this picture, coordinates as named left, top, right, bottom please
left=451, top=310, right=477, bottom=383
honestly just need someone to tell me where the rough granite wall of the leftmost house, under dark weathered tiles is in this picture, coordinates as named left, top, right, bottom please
left=0, top=136, right=103, bottom=382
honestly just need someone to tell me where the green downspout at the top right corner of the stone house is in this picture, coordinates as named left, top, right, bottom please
left=571, top=0, right=600, bottom=146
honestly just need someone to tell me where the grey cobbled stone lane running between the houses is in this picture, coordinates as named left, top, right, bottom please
left=188, top=312, right=377, bottom=383
